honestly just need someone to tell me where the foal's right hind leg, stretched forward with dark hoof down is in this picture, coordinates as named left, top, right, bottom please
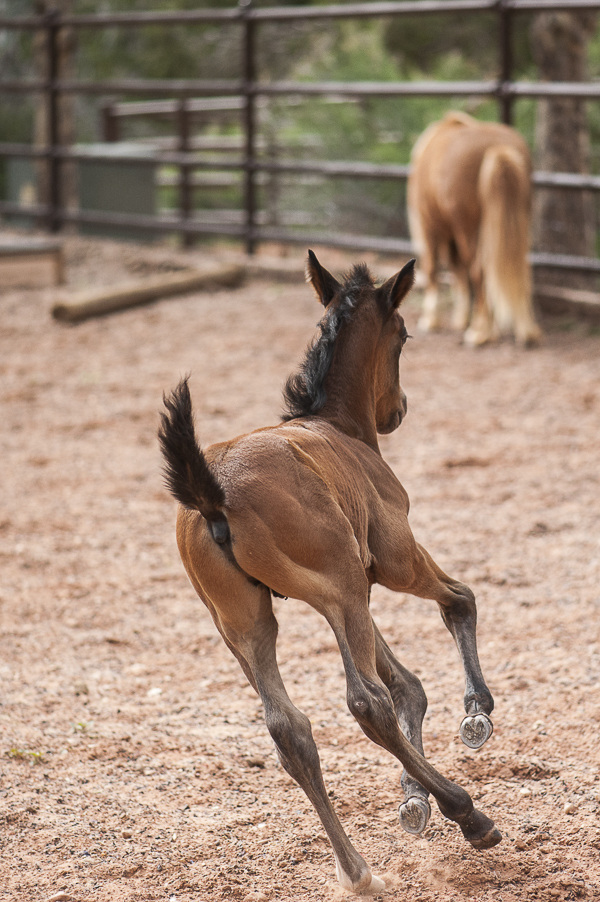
left=326, top=593, right=502, bottom=849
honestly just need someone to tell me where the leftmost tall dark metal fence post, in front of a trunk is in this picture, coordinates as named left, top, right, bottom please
left=46, top=9, right=62, bottom=232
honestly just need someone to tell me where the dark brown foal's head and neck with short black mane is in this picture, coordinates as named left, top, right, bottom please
left=284, top=251, right=415, bottom=434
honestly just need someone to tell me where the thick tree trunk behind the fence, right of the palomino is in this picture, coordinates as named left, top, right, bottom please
left=531, top=12, right=596, bottom=285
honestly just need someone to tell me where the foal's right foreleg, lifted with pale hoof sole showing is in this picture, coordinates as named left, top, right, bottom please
left=406, top=545, right=494, bottom=749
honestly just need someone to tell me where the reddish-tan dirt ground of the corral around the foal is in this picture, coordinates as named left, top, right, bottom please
left=0, top=239, right=600, bottom=902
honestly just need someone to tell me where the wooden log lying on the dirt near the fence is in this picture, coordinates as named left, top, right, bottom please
left=52, top=264, right=246, bottom=323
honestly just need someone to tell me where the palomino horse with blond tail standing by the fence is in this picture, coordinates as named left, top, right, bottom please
left=408, top=112, right=540, bottom=345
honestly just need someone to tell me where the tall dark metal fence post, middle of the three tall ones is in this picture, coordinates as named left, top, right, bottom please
left=239, top=0, right=257, bottom=254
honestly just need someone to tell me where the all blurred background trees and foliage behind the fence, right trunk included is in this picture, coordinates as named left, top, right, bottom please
left=0, top=0, right=600, bottom=254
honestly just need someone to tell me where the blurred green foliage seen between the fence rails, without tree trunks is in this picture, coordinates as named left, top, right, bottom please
left=0, top=0, right=600, bottom=235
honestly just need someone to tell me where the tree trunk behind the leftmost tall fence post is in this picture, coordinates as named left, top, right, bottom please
left=33, top=0, right=77, bottom=226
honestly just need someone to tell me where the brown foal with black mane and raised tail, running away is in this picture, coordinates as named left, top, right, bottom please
left=159, top=251, right=501, bottom=893
